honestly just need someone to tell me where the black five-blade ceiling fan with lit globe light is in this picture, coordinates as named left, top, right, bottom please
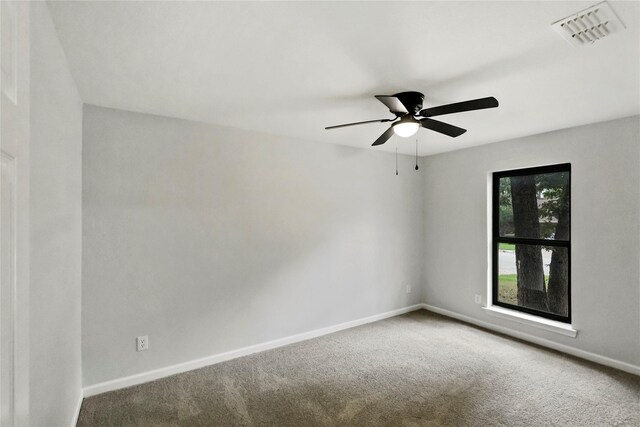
left=325, top=92, right=498, bottom=145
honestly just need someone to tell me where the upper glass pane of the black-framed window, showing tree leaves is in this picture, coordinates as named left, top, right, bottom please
left=498, top=172, right=571, bottom=240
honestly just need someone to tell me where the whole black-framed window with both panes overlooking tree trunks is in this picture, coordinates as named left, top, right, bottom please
left=493, top=164, right=571, bottom=323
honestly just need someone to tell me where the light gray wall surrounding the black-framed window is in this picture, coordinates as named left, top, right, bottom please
left=423, top=116, right=640, bottom=366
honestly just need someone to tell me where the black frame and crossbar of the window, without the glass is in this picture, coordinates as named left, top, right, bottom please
left=491, top=163, right=572, bottom=323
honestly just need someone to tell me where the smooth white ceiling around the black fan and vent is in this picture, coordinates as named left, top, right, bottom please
left=49, top=1, right=640, bottom=155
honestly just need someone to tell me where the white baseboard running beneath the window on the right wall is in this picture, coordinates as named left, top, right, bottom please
left=420, top=304, right=640, bottom=375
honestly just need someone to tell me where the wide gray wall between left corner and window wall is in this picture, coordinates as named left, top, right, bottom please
left=82, top=106, right=424, bottom=386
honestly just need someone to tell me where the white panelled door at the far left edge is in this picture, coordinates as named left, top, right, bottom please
left=0, top=0, right=31, bottom=427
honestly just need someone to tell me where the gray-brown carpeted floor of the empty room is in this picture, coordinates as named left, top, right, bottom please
left=78, top=311, right=640, bottom=427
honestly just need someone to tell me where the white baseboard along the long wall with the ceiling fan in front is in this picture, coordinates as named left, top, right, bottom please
left=84, top=304, right=424, bottom=398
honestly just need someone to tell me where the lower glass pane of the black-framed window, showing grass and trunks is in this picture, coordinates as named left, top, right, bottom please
left=497, top=243, right=569, bottom=317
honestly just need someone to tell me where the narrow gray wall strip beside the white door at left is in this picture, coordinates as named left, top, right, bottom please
left=30, top=2, right=82, bottom=426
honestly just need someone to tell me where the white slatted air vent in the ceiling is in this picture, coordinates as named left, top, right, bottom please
left=551, top=1, right=626, bottom=46
